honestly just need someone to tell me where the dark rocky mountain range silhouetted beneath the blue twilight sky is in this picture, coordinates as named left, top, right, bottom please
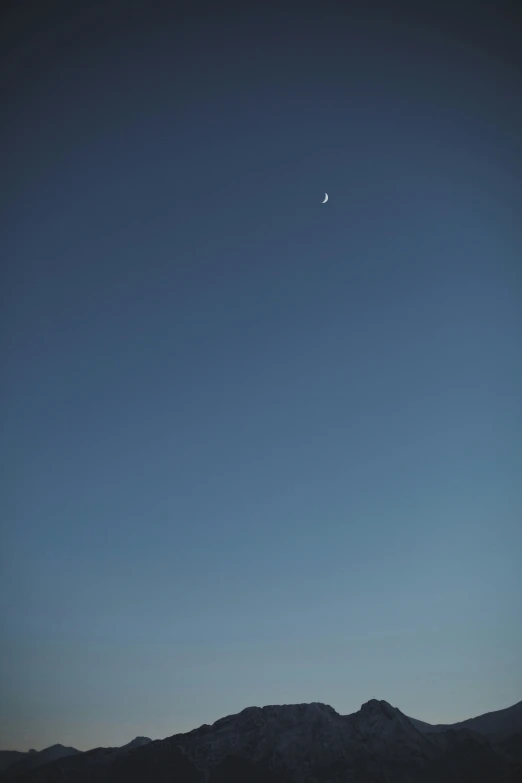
left=0, top=699, right=522, bottom=783
